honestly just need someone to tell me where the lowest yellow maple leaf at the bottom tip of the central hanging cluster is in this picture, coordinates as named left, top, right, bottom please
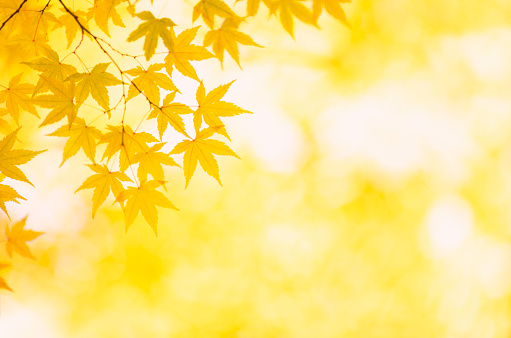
left=116, top=180, right=179, bottom=236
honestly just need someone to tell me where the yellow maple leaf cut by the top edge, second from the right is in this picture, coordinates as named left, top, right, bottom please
left=269, top=0, right=316, bottom=39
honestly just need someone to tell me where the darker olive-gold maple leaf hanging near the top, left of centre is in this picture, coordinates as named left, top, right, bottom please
left=127, top=11, right=176, bottom=61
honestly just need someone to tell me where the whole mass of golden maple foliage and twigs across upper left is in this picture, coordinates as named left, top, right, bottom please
left=0, top=0, right=348, bottom=289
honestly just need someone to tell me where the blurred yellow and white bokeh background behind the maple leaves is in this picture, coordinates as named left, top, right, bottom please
left=0, top=0, right=511, bottom=338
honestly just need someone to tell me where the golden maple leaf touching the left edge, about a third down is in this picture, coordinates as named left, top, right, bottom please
left=0, top=73, right=39, bottom=125
